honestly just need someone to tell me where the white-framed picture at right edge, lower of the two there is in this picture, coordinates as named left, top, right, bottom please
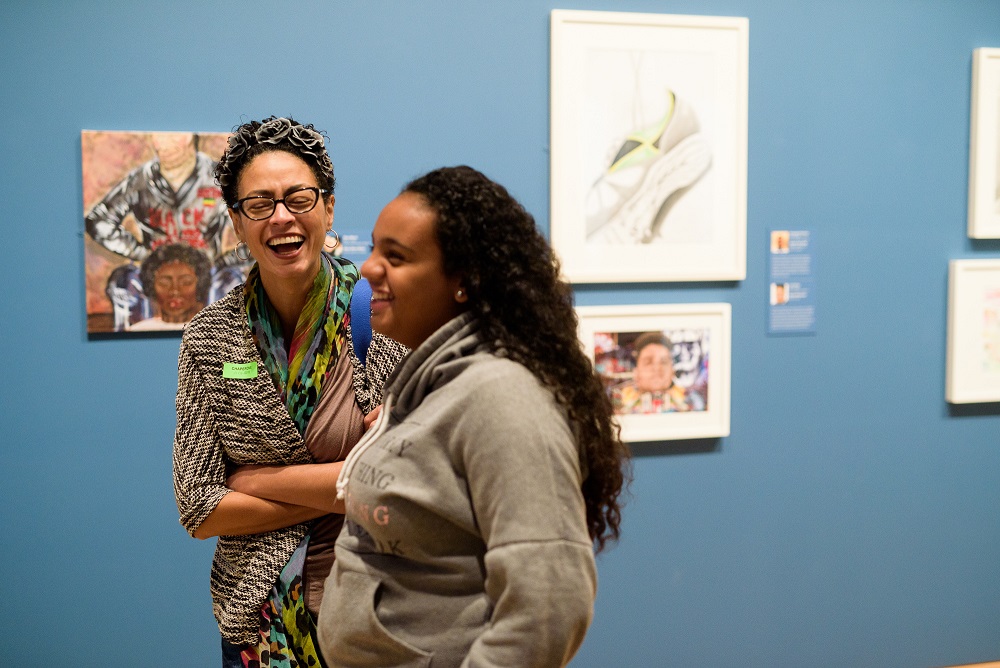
left=945, top=260, right=1000, bottom=404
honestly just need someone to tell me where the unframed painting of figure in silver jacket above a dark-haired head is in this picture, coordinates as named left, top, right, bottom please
left=81, top=130, right=249, bottom=334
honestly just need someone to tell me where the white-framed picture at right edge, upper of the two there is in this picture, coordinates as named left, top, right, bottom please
left=969, top=49, right=1000, bottom=239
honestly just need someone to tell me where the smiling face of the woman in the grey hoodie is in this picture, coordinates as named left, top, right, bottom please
left=361, top=193, right=467, bottom=348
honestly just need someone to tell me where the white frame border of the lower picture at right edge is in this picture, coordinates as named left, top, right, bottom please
left=945, top=258, right=1000, bottom=404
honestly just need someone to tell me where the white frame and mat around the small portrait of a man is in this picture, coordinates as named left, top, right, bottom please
left=576, top=302, right=732, bottom=443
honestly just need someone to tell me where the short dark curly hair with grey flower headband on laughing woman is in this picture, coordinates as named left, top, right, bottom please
left=215, top=116, right=337, bottom=208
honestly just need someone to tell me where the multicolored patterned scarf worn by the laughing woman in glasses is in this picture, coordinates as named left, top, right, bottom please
left=242, top=254, right=358, bottom=668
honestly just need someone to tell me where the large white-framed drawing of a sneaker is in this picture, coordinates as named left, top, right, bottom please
left=550, top=10, right=749, bottom=283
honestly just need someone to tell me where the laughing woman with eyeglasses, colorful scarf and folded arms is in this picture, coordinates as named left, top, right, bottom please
left=174, top=117, right=406, bottom=667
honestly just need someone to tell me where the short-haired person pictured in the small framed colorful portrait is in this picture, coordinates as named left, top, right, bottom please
left=611, top=332, right=705, bottom=415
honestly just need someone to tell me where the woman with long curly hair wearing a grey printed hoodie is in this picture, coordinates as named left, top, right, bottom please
left=319, top=167, right=628, bottom=667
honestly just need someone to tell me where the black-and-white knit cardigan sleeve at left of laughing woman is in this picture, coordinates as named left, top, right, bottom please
left=173, top=340, right=230, bottom=536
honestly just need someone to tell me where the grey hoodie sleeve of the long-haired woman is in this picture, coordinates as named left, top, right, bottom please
left=460, top=369, right=597, bottom=667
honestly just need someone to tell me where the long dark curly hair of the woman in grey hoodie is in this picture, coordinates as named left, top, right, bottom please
left=403, top=166, right=630, bottom=551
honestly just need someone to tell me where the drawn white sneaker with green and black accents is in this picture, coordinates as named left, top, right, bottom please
left=586, top=90, right=712, bottom=244
